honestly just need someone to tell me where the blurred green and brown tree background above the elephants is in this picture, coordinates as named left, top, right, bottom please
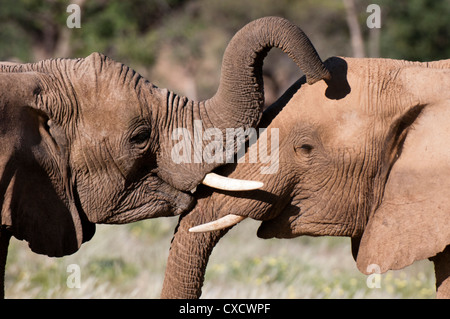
left=0, top=0, right=450, bottom=99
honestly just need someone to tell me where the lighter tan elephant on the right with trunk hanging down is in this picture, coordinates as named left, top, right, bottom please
left=161, top=57, right=450, bottom=298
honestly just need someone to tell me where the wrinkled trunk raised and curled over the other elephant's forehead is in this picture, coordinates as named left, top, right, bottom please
left=158, top=17, right=331, bottom=191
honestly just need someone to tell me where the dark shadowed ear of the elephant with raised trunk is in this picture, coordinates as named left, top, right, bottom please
left=0, top=72, right=95, bottom=256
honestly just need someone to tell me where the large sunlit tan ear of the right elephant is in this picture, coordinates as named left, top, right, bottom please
left=356, top=100, right=450, bottom=274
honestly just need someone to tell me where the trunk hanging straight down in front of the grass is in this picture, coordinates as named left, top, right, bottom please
left=161, top=199, right=230, bottom=299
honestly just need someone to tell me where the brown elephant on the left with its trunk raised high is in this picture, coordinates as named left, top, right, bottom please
left=0, top=17, right=329, bottom=294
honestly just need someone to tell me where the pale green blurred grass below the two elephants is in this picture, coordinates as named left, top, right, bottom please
left=5, top=218, right=435, bottom=298
